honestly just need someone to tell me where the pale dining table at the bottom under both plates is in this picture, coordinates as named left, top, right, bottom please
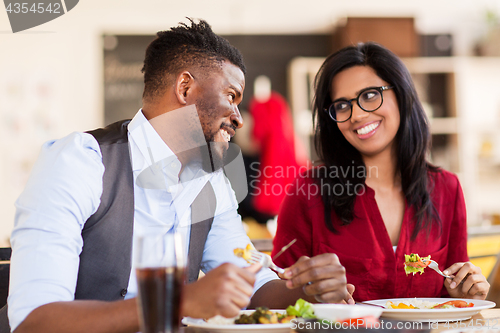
left=179, top=308, right=500, bottom=333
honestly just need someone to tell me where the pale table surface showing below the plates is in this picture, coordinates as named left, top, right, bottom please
left=179, top=308, right=500, bottom=333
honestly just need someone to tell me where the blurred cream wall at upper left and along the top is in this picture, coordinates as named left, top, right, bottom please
left=0, top=0, right=500, bottom=245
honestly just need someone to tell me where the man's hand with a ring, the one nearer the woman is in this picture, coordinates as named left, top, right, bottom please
left=283, top=253, right=348, bottom=304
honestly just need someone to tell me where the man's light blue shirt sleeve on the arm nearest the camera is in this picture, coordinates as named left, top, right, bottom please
left=8, top=133, right=104, bottom=330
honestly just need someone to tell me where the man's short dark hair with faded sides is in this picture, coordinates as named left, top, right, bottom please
left=142, top=18, right=246, bottom=99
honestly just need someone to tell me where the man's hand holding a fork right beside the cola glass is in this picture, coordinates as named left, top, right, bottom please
left=181, top=264, right=261, bottom=318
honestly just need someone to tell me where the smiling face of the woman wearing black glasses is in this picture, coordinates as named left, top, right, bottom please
left=330, top=66, right=400, bottom=156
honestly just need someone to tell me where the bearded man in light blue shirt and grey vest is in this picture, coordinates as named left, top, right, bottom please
left=8, top=21, right=352, bottom=333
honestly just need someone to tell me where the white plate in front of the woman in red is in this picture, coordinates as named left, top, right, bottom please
left=363, top=298, right=495, bottom=322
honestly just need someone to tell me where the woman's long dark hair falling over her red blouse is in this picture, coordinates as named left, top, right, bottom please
left=313, top=42, right=441, bottom=239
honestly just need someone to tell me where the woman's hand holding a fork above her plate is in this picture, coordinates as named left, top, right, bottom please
left=443, top=261, right=490, bottom=299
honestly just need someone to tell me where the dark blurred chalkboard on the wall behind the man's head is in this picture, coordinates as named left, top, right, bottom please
left=103, top=34, right=332, bottom=124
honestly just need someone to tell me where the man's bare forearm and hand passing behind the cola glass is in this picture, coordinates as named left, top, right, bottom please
left=14, top=264, right=260, bottom=333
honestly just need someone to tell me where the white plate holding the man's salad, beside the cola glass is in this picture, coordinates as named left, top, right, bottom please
left=182, top=310, right=293, bottom=333
